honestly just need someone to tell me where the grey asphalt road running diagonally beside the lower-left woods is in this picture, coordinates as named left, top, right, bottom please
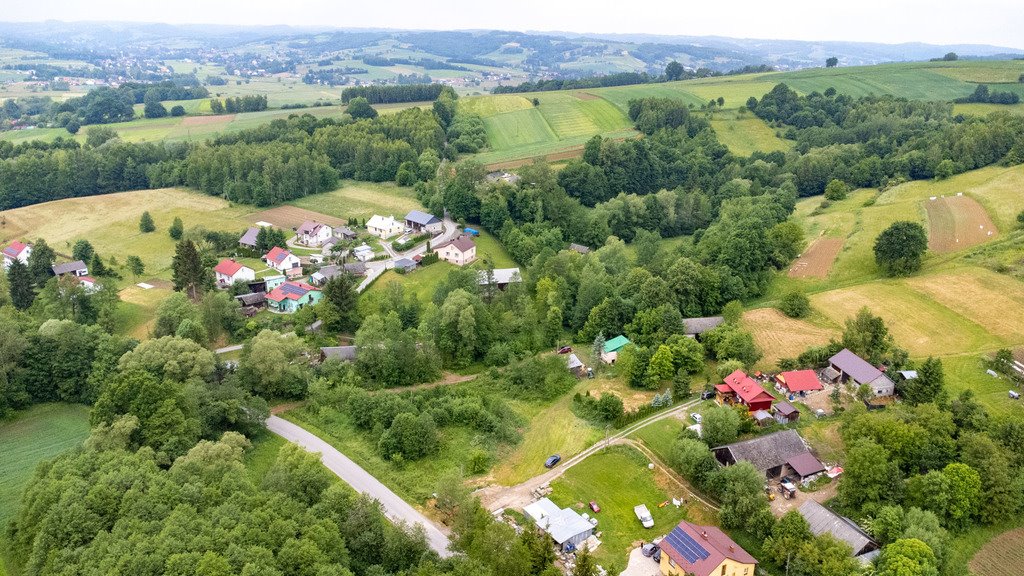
left=266, top=416, right=452, bottom=558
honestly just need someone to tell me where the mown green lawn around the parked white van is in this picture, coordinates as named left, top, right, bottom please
left=551, top=446, right=687, bottom=573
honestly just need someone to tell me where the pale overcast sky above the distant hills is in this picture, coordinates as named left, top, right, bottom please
left=6, top=0, right=1024, bottom=49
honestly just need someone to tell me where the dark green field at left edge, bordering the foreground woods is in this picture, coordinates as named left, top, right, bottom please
left=0, top=404, right=89, bottom=574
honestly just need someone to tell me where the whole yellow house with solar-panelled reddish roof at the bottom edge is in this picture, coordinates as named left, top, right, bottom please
left=658, top=520, right=758, bottom=576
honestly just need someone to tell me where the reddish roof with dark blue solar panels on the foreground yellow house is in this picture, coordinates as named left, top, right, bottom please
left=659, top=520, right=758, bottom=576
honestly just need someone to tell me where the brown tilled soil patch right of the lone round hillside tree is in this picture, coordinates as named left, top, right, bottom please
left=925, top=196, right=998, bottom=252
